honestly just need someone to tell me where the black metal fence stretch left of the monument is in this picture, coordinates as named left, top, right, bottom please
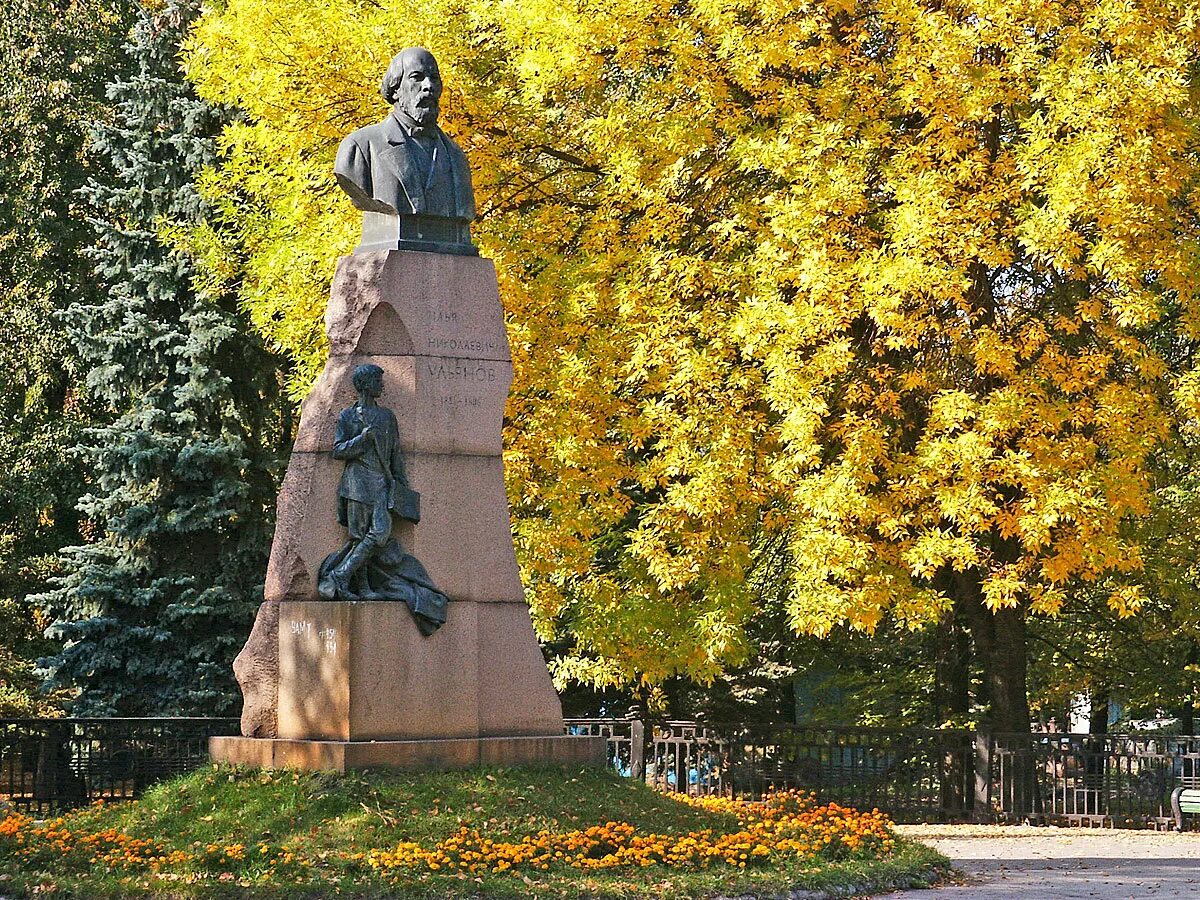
left=0, top=719, right=239, bottom=812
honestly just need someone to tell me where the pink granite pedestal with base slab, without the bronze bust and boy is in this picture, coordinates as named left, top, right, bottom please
left=211, top=251, right=605, bottom=769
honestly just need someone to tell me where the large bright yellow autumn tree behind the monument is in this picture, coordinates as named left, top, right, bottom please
left=188, top=0, right=1200, bottom=728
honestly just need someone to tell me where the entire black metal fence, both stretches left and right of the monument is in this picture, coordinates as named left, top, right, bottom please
left=0, top=718, right=1200, bottom=827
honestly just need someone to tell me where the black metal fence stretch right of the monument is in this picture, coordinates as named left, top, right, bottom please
left=568, top=719, right=1200, bottom=827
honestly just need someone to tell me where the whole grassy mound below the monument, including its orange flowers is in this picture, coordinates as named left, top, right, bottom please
left=0, top=767, right=946, bottom=898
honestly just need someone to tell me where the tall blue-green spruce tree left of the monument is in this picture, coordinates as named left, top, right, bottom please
left=41, top=0, right=280, bottom=715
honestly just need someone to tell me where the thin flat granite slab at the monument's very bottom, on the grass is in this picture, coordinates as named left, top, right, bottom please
left=209, top=734, right=607, bottom=772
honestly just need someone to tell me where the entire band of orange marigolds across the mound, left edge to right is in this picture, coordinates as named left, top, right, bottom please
left=0, top=792, right=895, bottom=884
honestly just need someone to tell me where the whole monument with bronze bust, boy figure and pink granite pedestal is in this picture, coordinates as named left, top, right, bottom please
left=210, top=48, right=605, bottom=770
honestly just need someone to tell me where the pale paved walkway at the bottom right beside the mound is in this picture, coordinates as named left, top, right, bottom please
left=890, top=826, right=1200, bottom=900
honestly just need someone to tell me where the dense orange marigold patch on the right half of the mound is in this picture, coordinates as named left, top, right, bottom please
left=366, top=791, right=895, bottom=876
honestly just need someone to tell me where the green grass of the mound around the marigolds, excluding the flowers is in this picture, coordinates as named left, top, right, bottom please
left=0, top=767, right=948, bottom=899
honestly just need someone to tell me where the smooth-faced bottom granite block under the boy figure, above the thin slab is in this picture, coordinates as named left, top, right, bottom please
left=276, top=601, right=563, bottom=743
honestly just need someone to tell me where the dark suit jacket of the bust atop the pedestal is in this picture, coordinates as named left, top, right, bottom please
left=334, top=114, right=475, bottom=222
